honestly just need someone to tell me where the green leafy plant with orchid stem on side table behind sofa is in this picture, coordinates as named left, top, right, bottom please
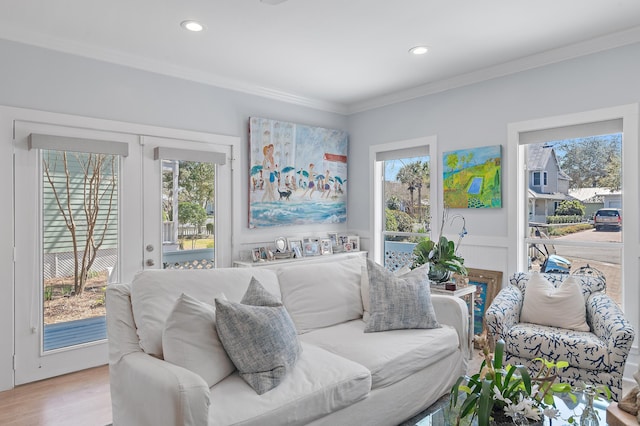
left=412, top=210, right=467, bottom=282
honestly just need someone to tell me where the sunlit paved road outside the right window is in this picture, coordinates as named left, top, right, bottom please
left=536, top=229, right=622, bottom=306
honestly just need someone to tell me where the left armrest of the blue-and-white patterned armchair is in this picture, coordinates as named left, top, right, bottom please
left=484, top=285, right=524, bottom=340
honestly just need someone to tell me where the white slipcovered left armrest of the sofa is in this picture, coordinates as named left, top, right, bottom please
left=109, top=352, right=210, bottom=426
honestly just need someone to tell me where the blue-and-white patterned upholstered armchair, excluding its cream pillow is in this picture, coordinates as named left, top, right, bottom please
left=485, top=272, right=635, bottom=401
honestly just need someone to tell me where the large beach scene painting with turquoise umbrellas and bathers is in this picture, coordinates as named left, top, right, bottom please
left=249, top=117, right=348, bottom=228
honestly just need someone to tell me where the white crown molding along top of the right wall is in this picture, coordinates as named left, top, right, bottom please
left=347, top=26, right=640, bottom=114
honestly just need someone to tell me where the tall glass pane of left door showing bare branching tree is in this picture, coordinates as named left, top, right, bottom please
left=40, top=150, right=120, bottom=352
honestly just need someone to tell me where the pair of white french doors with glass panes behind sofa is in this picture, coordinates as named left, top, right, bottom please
left=14, top=117, right=235, bottom=385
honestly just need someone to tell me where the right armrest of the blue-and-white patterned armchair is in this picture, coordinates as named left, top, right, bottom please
left=587, top=293, right=635, bottom=373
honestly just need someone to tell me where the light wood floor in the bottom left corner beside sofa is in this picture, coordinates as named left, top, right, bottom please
left=0, top=365, right=112, bottom=426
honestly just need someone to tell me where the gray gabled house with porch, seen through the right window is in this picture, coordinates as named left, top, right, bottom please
left=527, top=144, right=573, bottom=223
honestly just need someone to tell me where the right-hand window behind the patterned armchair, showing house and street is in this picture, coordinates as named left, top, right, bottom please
left=520, top=120, right=624, bottom=305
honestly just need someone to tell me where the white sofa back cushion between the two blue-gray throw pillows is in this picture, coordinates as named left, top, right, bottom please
left=278, top=256, right=365, bottom=333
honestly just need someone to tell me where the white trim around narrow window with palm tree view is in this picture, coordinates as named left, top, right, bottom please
left=369, top=135, right=442, bottom=264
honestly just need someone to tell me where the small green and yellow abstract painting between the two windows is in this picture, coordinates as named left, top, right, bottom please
left=442, top=145, right=502, bottom=209
